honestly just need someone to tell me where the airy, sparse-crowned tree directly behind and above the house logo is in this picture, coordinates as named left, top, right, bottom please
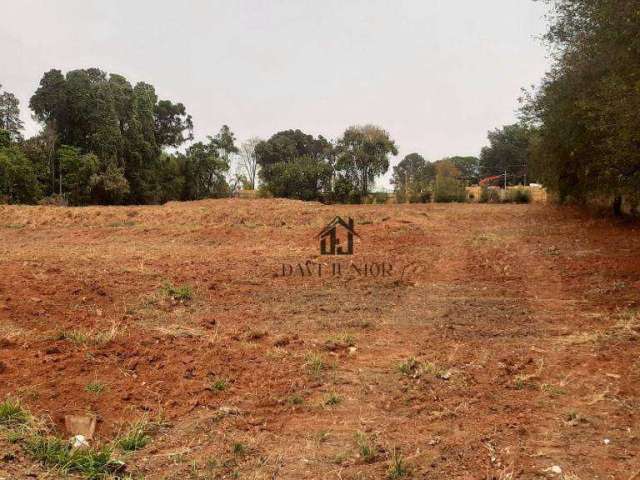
left=336, top=125, right=398, bottom=197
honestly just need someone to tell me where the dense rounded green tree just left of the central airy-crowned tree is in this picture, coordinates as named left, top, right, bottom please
left=254, top=130, right=333, bottom=200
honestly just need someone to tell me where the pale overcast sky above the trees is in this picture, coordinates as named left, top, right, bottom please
left=0, top=0, right=550, bottom=187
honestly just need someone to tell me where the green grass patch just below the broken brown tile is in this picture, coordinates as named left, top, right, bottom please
left=24, top=434, right=124, bottom=480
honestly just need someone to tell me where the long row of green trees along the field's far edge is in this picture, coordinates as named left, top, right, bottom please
left=0, top=68, right=530, bottom=205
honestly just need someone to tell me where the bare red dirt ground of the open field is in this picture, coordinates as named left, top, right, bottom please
left=0, top=199, right=640, bottom=480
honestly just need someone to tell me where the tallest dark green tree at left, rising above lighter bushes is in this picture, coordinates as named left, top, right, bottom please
left=29, top=68, right=193, bottom=203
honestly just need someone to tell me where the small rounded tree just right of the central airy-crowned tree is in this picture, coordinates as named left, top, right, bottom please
left=391, top=153, right=435, bottom=202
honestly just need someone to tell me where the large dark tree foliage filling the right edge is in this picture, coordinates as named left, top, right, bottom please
left=523, top=0, right=640, bottom=209
